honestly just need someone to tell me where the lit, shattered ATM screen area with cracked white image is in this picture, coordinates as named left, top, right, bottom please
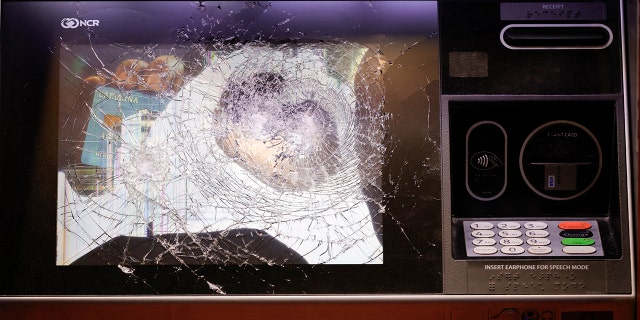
left=59, top=43, right=386, bottom=264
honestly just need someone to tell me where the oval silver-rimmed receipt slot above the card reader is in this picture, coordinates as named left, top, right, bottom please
left=500, top=24, right=612, bottom=50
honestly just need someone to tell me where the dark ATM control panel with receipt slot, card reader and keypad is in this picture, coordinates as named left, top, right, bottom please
left=440, top=2, right=634, bottom=302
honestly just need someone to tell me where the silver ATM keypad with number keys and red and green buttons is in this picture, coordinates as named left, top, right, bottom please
left=463, top=220, right=604, bottom=257
